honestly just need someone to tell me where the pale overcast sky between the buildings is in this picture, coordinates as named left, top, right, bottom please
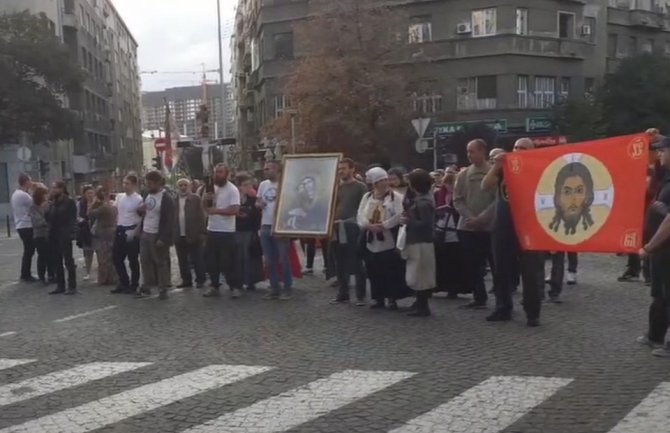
left=112, top=0, right=237, bottom=91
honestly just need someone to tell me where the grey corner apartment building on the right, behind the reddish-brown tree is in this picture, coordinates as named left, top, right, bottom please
left=232, top=0, right=670, bottom=164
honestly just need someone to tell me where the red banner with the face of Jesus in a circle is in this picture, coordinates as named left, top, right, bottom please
left=504, top=134, right=649, bottom=253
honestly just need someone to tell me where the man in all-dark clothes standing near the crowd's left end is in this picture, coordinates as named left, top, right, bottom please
left=46, top=181, right=77, bottom=295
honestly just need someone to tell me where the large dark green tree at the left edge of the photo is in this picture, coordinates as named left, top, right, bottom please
left=0, top=12, right=83, bottom=142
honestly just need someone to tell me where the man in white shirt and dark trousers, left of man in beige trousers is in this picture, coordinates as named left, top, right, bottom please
left=112, top=174, right=142, bottom=293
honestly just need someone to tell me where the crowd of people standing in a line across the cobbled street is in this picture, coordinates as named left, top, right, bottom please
left=12, top=130, right=670, bottom=356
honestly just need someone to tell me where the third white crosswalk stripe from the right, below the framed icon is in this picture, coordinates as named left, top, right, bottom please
left=184, top=370, right=414, bottom=433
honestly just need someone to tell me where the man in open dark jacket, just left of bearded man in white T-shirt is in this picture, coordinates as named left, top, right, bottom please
left=175, top=179, right=207, bottom=289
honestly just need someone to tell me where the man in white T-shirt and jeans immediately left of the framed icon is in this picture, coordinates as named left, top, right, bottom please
left=256, top=161, right=293, bottom=300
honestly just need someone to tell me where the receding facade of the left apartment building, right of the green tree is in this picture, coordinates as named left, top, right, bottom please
left=62, top=0, right=142, bottom=184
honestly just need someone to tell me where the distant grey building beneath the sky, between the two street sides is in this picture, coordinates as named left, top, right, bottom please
left=142, top=83, right=235, bottom=139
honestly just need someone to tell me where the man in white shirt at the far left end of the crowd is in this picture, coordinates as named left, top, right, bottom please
left=11, top=173, right=37, bottom=283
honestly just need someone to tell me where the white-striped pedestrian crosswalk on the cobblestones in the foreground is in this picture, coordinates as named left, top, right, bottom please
left=0, top=358, right=670, bottom=433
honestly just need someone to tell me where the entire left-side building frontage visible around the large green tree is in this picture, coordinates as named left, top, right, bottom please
left=0, top=0, right=142, bottom=206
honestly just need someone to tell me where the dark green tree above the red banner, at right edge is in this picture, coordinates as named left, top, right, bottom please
left=600, top=54, right=670, bottom=135
